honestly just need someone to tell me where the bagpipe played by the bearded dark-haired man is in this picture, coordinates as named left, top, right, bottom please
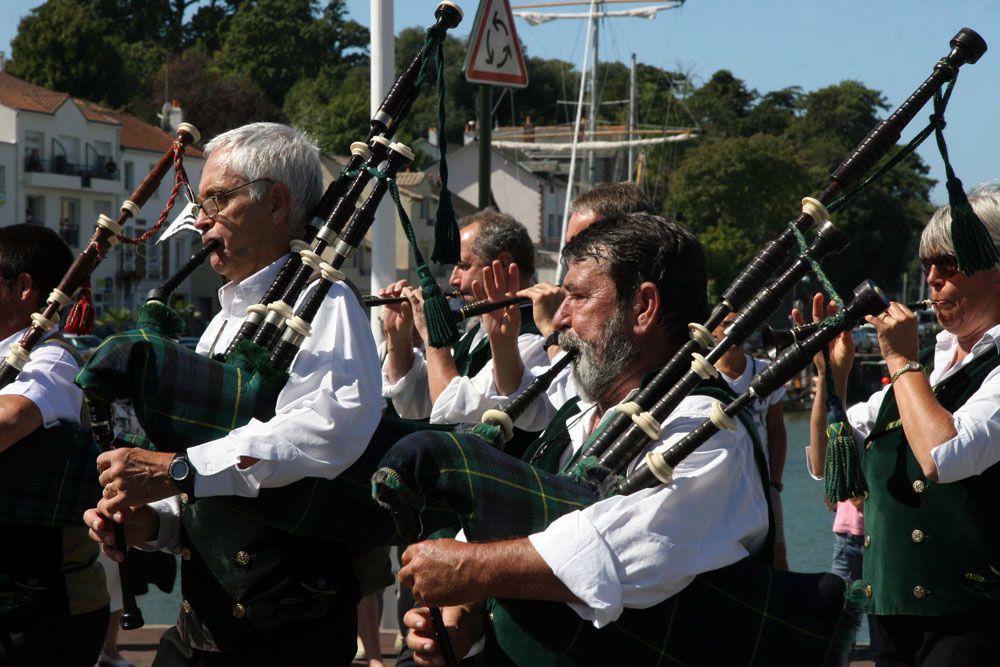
left=372, top=29, right=986, bottom=664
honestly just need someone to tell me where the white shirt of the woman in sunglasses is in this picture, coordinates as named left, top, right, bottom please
left=847, top=324, right=1000, bottom=484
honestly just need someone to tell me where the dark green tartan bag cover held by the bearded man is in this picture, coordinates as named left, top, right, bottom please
left=372, top=402, right=856, bottom=665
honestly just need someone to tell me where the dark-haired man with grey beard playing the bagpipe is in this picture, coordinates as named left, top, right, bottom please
left=399, top=213, right=768, bottom=664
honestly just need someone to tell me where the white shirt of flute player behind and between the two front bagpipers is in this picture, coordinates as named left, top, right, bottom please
left=382, top=325, right=545, bottom=424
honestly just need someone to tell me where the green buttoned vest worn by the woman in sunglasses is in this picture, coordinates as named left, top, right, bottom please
left=863, top=348, right=1000, bottom=616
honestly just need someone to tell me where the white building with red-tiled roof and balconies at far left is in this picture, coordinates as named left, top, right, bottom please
left=0, top=72, right=211, bottom=328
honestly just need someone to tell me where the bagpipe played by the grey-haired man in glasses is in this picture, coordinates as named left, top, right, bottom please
left=68, top=2, right=462, bottom=628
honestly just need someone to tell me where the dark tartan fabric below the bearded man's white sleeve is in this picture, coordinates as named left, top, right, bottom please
left=485, top=559, right=854, bottom=667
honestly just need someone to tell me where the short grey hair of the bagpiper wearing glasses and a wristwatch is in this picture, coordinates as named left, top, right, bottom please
left=205, top=123, right=323, bottom=237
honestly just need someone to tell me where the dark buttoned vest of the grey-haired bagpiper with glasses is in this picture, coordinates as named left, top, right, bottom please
left=177, top=498, right=360, bottom=653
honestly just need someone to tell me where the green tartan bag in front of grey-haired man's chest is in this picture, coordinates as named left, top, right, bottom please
left=76, top=327, right=284, bottom=451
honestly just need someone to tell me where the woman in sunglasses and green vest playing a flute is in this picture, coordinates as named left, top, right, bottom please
left=793, top=185, right=1000, bottom=665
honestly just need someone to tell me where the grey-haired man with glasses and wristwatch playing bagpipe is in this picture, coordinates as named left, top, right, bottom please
left=85, top=123, right=382, bottom=665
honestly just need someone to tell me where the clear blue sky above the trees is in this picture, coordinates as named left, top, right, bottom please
left=0, top=0, right=1000, bottom=203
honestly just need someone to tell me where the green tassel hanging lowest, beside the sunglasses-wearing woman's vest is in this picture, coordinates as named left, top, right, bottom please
left=823, top=360, right=868, bottom=507
